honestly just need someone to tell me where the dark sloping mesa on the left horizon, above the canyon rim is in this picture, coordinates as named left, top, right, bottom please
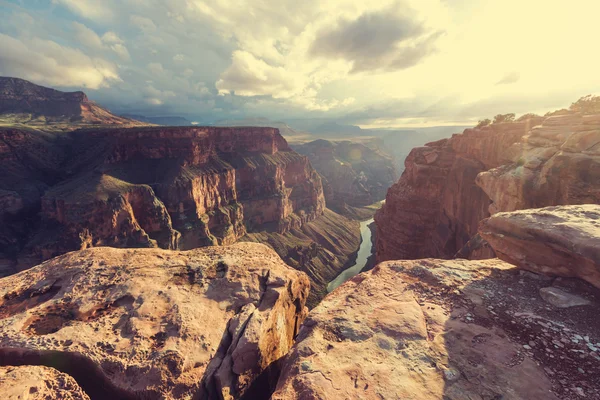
left=0, top=77, right=144, bottom=126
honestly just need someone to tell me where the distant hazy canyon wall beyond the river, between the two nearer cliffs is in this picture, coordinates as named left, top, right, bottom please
left=294, top=140, right=397, bottom=213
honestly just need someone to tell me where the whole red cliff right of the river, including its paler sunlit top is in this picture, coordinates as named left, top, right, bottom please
left=376, top=114, right=600, bottom=261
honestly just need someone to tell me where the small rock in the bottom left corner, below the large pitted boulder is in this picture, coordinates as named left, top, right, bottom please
left=0, top=366, right=90, bottom=400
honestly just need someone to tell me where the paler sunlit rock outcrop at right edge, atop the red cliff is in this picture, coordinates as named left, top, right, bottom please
left=477, top=114, right=600, bottom=214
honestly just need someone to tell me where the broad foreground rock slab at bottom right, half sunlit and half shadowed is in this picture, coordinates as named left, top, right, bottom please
left=273, top=259, right=600, bottom=400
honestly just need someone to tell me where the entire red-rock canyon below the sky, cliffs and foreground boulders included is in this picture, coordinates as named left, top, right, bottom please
left=0, top=81, right=600, bottom=400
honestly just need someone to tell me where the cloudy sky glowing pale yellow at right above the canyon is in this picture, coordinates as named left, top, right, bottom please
left=0, top=0, right=600, bottom=128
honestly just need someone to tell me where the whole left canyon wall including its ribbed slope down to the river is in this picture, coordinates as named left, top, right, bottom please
left=0, top=127, right=360, bottom=304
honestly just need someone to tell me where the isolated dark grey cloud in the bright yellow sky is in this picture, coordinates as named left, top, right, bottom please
left=309, top=4, right=443, bottom=72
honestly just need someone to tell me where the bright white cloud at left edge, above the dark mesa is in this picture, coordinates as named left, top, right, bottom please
left=0, top=33, right=120, bottom=89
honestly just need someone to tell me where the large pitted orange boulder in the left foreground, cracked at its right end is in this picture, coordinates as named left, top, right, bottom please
left=0, top=243, right=309, bottom=399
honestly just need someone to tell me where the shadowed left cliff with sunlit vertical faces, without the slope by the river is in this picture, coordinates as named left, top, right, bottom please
left=0, top=127, right=325, bottom=268
